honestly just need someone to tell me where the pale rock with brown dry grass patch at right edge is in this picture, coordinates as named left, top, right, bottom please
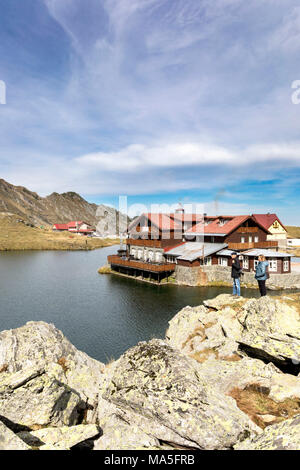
left=193, top=357, right=300, bottom=428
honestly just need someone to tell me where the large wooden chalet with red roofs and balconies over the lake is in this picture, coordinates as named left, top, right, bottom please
left=108, top=211, right=291, bottom=281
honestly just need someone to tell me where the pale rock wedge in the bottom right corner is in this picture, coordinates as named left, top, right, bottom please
left=234, top=414, right=300, bottom=450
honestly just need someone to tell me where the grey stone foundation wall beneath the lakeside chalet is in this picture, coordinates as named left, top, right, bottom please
left=175, top=265, right=300, bottom=289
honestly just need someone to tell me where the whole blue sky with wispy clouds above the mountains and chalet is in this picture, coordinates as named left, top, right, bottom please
left=0, top=0, right=300, bottom=225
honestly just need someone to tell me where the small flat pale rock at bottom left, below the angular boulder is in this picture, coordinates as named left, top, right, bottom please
left=18, top=424, right=100, bottom=450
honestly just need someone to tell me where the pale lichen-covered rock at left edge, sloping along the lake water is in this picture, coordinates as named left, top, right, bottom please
left=0, top=322, right=104, bottom=422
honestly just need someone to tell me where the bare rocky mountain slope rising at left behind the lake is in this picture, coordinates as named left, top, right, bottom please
left=0, top=179, right=127, bottom=231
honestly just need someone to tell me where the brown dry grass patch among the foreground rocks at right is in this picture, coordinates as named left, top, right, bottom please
left=229, top=384, right=300, bottom=429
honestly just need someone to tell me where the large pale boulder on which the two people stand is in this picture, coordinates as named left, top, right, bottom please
left=166, top=294, right=300, bottom=374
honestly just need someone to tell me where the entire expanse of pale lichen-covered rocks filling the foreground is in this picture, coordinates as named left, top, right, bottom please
left=0, top=295, right=300, bottom=450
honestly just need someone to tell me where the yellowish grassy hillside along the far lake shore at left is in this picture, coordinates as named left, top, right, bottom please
left=0, top=213, right=118, bottom=251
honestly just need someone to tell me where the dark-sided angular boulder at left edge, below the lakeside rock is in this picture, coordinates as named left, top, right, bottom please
left=0, top=368, right=84, bottom=430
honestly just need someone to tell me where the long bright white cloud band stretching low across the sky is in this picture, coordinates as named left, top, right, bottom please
left=76, top=142, right=300, bottom=173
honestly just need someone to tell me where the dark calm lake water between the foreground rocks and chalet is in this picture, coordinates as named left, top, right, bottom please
left=0, top=246, right=286, bottom=362
